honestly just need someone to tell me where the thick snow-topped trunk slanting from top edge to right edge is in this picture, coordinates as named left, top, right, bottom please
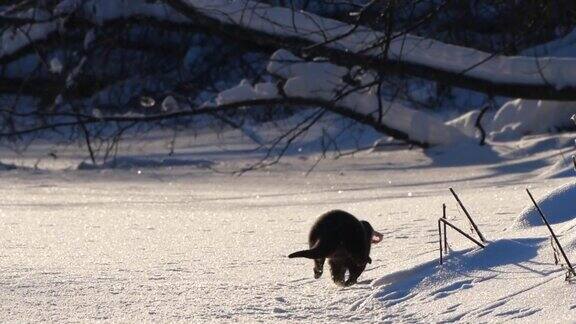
left=166, top=0, right=576, bottom=100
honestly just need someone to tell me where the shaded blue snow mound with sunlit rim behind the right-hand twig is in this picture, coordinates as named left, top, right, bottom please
left=512, top=182, right=576, bottom=229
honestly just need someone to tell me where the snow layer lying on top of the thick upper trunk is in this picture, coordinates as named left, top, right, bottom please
left=184, top=0, right=576, bottom=89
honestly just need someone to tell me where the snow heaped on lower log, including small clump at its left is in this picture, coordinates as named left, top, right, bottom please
left=214, top=50, right=468, bottom=146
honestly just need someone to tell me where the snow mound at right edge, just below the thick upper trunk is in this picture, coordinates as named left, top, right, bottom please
left=490, top=99, right=576, bottom=141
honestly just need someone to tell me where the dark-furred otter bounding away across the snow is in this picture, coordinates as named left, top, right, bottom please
left=288, top=210, right=383, bottom=286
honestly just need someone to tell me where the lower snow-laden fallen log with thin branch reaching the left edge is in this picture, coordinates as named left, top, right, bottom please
left=0, top=50, right=470, bottom=147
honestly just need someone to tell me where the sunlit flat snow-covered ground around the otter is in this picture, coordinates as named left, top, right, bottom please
left=0, top=127, right=576, bottom=322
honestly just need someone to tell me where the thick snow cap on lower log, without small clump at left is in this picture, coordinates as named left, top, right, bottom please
left=267, top=50, right=467, bottom=145
